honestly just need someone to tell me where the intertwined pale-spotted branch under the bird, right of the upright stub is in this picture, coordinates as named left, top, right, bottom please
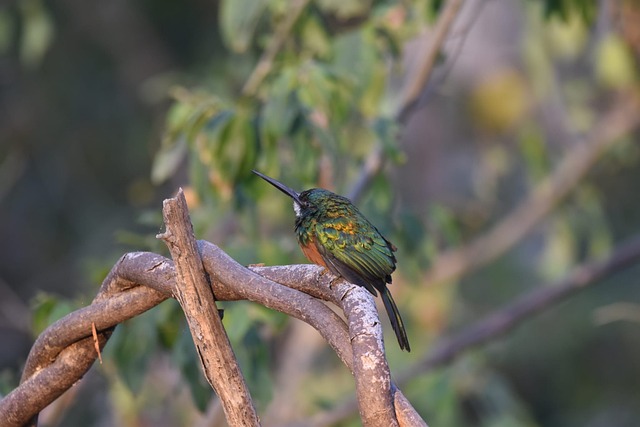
left=200, top=241, right=424, bottom=426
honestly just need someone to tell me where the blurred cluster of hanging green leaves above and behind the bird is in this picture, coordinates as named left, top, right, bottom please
left=153, top=1, right=427, bottom=206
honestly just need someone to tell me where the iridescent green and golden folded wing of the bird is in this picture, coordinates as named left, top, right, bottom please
left=316, top=218, right=396, bottom=295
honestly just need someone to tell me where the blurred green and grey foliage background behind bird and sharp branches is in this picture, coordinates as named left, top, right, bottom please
left=0, top=0, right=640, bottom=427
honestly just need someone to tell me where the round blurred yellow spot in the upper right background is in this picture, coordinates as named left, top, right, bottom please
left=470, top=68, right=529, bottom=133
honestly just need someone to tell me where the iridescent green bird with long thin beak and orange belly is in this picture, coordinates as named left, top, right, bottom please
left=252, top=170, right=411, bottom=352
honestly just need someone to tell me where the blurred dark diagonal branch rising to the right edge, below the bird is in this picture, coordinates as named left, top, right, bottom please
left=310, top=235, right=640, bottom=427
